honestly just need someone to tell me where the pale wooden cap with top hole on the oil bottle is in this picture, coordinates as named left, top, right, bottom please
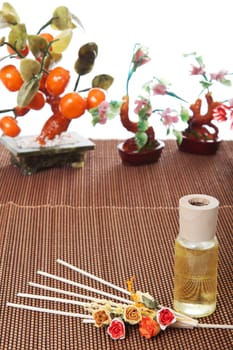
left=179, top=194, right=219, bottom=242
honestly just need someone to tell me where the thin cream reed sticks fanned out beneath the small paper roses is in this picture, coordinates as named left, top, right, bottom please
left=7, top=259, right=233, bottom=329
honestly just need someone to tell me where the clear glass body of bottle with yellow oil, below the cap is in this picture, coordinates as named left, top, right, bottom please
left=174, top=237, right=218, bottom=317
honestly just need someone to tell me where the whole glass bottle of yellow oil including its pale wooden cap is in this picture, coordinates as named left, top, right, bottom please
left=174, top=194, right=219, bottom=317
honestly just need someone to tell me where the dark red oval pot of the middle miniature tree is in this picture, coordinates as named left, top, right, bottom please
left=117, top=140, right=165, bottom=165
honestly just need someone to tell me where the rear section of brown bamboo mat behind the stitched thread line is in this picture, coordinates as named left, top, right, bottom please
left=0, top=140, right=233, bottom=207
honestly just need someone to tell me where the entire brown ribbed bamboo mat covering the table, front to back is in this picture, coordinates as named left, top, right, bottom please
left=0, top=140, right=233, bottom=350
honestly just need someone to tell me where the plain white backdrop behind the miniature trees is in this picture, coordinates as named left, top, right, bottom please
left=0, top=0, right=233, bottom=139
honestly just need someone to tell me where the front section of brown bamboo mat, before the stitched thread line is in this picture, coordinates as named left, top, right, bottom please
left=0, top=204, right=233, bottom=350
